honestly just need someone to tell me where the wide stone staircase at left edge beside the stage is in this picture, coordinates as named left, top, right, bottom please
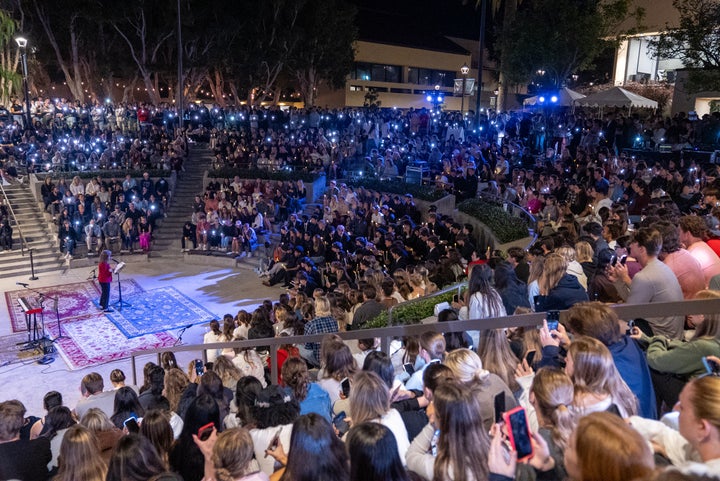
left=0, top=184, right=63, bottom=278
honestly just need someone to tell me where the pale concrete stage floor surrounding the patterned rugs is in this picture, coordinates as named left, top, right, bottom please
left=0, top=253, right=283, bottom=416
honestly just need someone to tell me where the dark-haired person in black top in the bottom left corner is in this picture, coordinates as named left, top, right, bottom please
left=0, top=399, right=52, bottom=481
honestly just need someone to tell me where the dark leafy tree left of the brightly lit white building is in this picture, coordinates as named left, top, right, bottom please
left=500, top=0, right=640, bottom=88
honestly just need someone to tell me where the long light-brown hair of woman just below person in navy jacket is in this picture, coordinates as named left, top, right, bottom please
left=568, top=336, right=638, bottom=416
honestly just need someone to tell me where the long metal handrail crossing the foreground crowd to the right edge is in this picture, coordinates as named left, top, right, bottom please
left=130, top=299, right=720, bottom=384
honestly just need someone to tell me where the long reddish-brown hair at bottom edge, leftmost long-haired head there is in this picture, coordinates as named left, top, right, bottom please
left=53, top=424, right=107, bottom=481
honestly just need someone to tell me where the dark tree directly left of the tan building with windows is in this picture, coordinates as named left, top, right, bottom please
left=289, top=0, right=357, bottom=107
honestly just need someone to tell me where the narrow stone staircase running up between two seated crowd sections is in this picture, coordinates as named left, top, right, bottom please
left=150, top=144, right=213, bottom=253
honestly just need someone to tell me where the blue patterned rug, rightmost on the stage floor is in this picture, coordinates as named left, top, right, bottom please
left=106, top=287, right=217, bottom=339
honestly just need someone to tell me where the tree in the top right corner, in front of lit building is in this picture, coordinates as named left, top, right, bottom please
left=651, top=0, right=720, bottom=92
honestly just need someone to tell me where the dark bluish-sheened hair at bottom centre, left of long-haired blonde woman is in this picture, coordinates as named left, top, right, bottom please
left=346, top=422, right=410, bottom=481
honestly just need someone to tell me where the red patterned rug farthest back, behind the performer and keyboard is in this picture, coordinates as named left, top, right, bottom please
left=5, top=279, right=143, bottom=332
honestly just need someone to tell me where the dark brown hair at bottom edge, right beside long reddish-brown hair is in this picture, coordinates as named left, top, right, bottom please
left=105, top=434, right=165, bottom=481
